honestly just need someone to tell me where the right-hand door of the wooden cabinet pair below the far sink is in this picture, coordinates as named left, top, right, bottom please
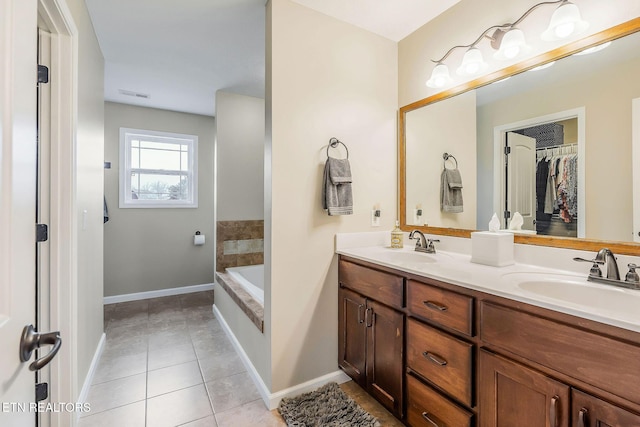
left=366, top=301, right=404, bottom=418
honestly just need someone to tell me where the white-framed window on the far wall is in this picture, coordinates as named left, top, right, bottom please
left=120, top=128, right=198, bottom=208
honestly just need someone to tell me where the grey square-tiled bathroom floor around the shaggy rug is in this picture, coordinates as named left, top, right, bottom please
left=80, top=292, right=402, bottom=427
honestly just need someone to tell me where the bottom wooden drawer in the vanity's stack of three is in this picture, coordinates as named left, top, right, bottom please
left=407, top=375, right=473, bottom=427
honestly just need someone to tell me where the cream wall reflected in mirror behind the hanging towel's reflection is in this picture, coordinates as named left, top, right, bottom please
left=405, top=92, right=477, bottom=230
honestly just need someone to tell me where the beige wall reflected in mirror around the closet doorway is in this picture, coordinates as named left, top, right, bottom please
left=478, top=55, right=640, bottom=241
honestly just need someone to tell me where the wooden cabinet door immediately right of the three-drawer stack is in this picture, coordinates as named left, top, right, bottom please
left=478, top=350, right=569, bottom=427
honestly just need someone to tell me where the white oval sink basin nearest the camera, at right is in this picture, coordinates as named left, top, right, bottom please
left=503, top=273, right=640, bottom=311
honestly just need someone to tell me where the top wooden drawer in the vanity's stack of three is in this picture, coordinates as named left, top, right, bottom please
left=407, top=280, right=473, bottom=336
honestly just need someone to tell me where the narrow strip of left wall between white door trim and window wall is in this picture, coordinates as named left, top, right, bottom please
left=67, top=0, right=104, bottom=400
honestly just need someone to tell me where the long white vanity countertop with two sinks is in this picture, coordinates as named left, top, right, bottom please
left=336, top=246, right=640, bottom=332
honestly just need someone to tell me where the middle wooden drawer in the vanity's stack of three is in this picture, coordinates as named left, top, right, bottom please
left=407, top=319, right=473, bottom=406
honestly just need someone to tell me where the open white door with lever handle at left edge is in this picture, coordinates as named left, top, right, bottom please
left=0, top=0, right=37, bottom=427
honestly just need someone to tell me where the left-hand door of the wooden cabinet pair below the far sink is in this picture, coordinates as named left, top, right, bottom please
left=338, top=288, right=367, bottom=388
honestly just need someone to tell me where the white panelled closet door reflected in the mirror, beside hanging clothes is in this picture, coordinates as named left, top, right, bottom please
left=505, top=132, right=536, bottom=230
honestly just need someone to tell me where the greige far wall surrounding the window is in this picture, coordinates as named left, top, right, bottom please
left=104, top=102, right=215, bottom=296
